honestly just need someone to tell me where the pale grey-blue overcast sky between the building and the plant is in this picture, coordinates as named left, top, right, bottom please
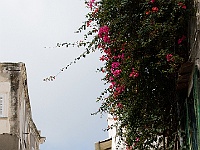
left=0, top=0, right=108, bottom=150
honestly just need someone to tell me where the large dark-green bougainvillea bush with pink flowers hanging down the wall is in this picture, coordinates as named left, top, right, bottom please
left=44, top=0, right=194, bottom=150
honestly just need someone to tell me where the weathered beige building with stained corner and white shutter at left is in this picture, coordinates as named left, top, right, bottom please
left=0, top=63, right=45, bottom=150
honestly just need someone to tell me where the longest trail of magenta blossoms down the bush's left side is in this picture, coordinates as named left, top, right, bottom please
left=98, top=25, right=139, bottom=101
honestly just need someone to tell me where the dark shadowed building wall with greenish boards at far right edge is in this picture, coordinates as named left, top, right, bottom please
left=179, top=0, right=200, bottom=150
